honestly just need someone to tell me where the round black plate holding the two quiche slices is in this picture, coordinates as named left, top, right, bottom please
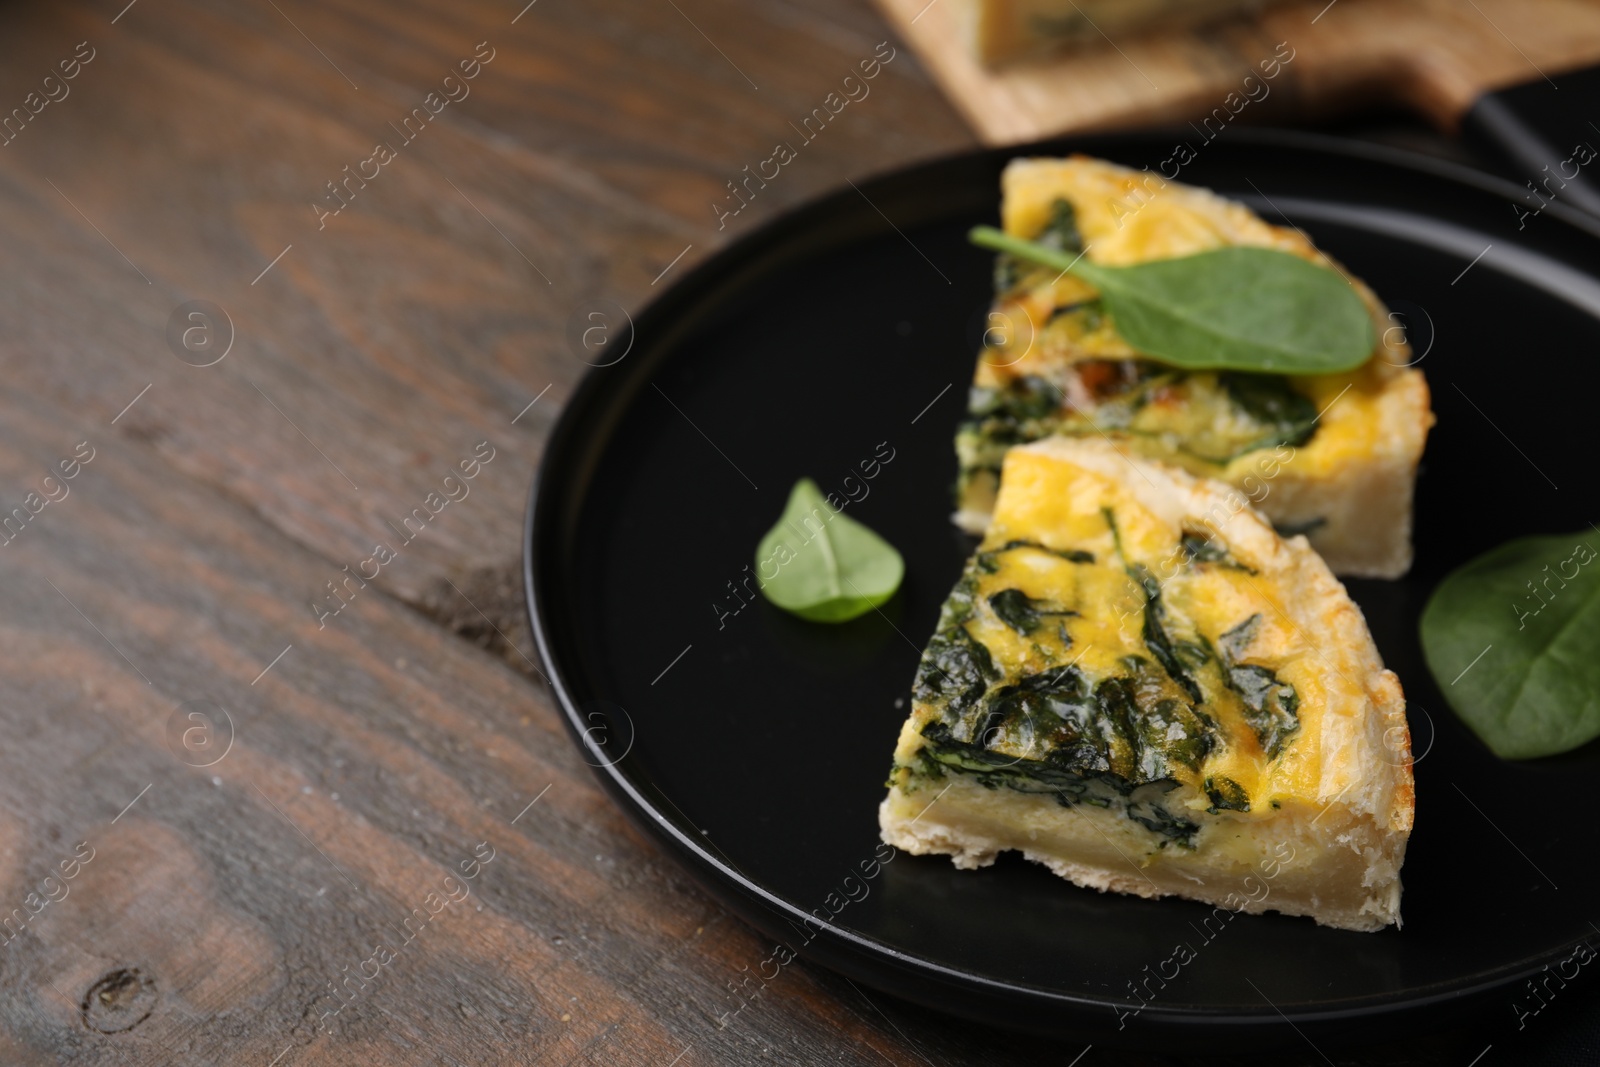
left=526, top=130, right=1600, bottom=1049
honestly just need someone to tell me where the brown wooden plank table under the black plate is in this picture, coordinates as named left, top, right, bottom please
left=0, top=0, right=1574, bottom=1067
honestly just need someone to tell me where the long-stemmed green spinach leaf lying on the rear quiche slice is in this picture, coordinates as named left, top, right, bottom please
left=971, top=226, right=1376, bottom=374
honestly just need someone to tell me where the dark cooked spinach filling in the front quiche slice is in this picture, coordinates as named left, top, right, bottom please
left=914, top=509, right=1299, bottom=848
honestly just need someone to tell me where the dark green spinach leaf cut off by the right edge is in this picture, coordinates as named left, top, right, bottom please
left=1421, top=530, right=1600, bottom=760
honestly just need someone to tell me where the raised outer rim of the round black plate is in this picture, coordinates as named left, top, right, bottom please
left=522, top=126, right=1600, bottom=1046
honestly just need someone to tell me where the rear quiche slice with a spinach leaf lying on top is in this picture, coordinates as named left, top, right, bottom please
left=955, top=157, right=1434, bottom=577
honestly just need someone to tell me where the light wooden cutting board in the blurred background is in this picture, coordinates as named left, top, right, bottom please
left=877, top=0, right=1600, bottom=144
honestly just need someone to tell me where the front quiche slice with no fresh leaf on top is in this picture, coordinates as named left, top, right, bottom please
left=878, top=437, right=1413, bottom=929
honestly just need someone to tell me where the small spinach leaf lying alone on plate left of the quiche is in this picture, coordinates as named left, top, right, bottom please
left=755, top=478, right=906, bottom=622
